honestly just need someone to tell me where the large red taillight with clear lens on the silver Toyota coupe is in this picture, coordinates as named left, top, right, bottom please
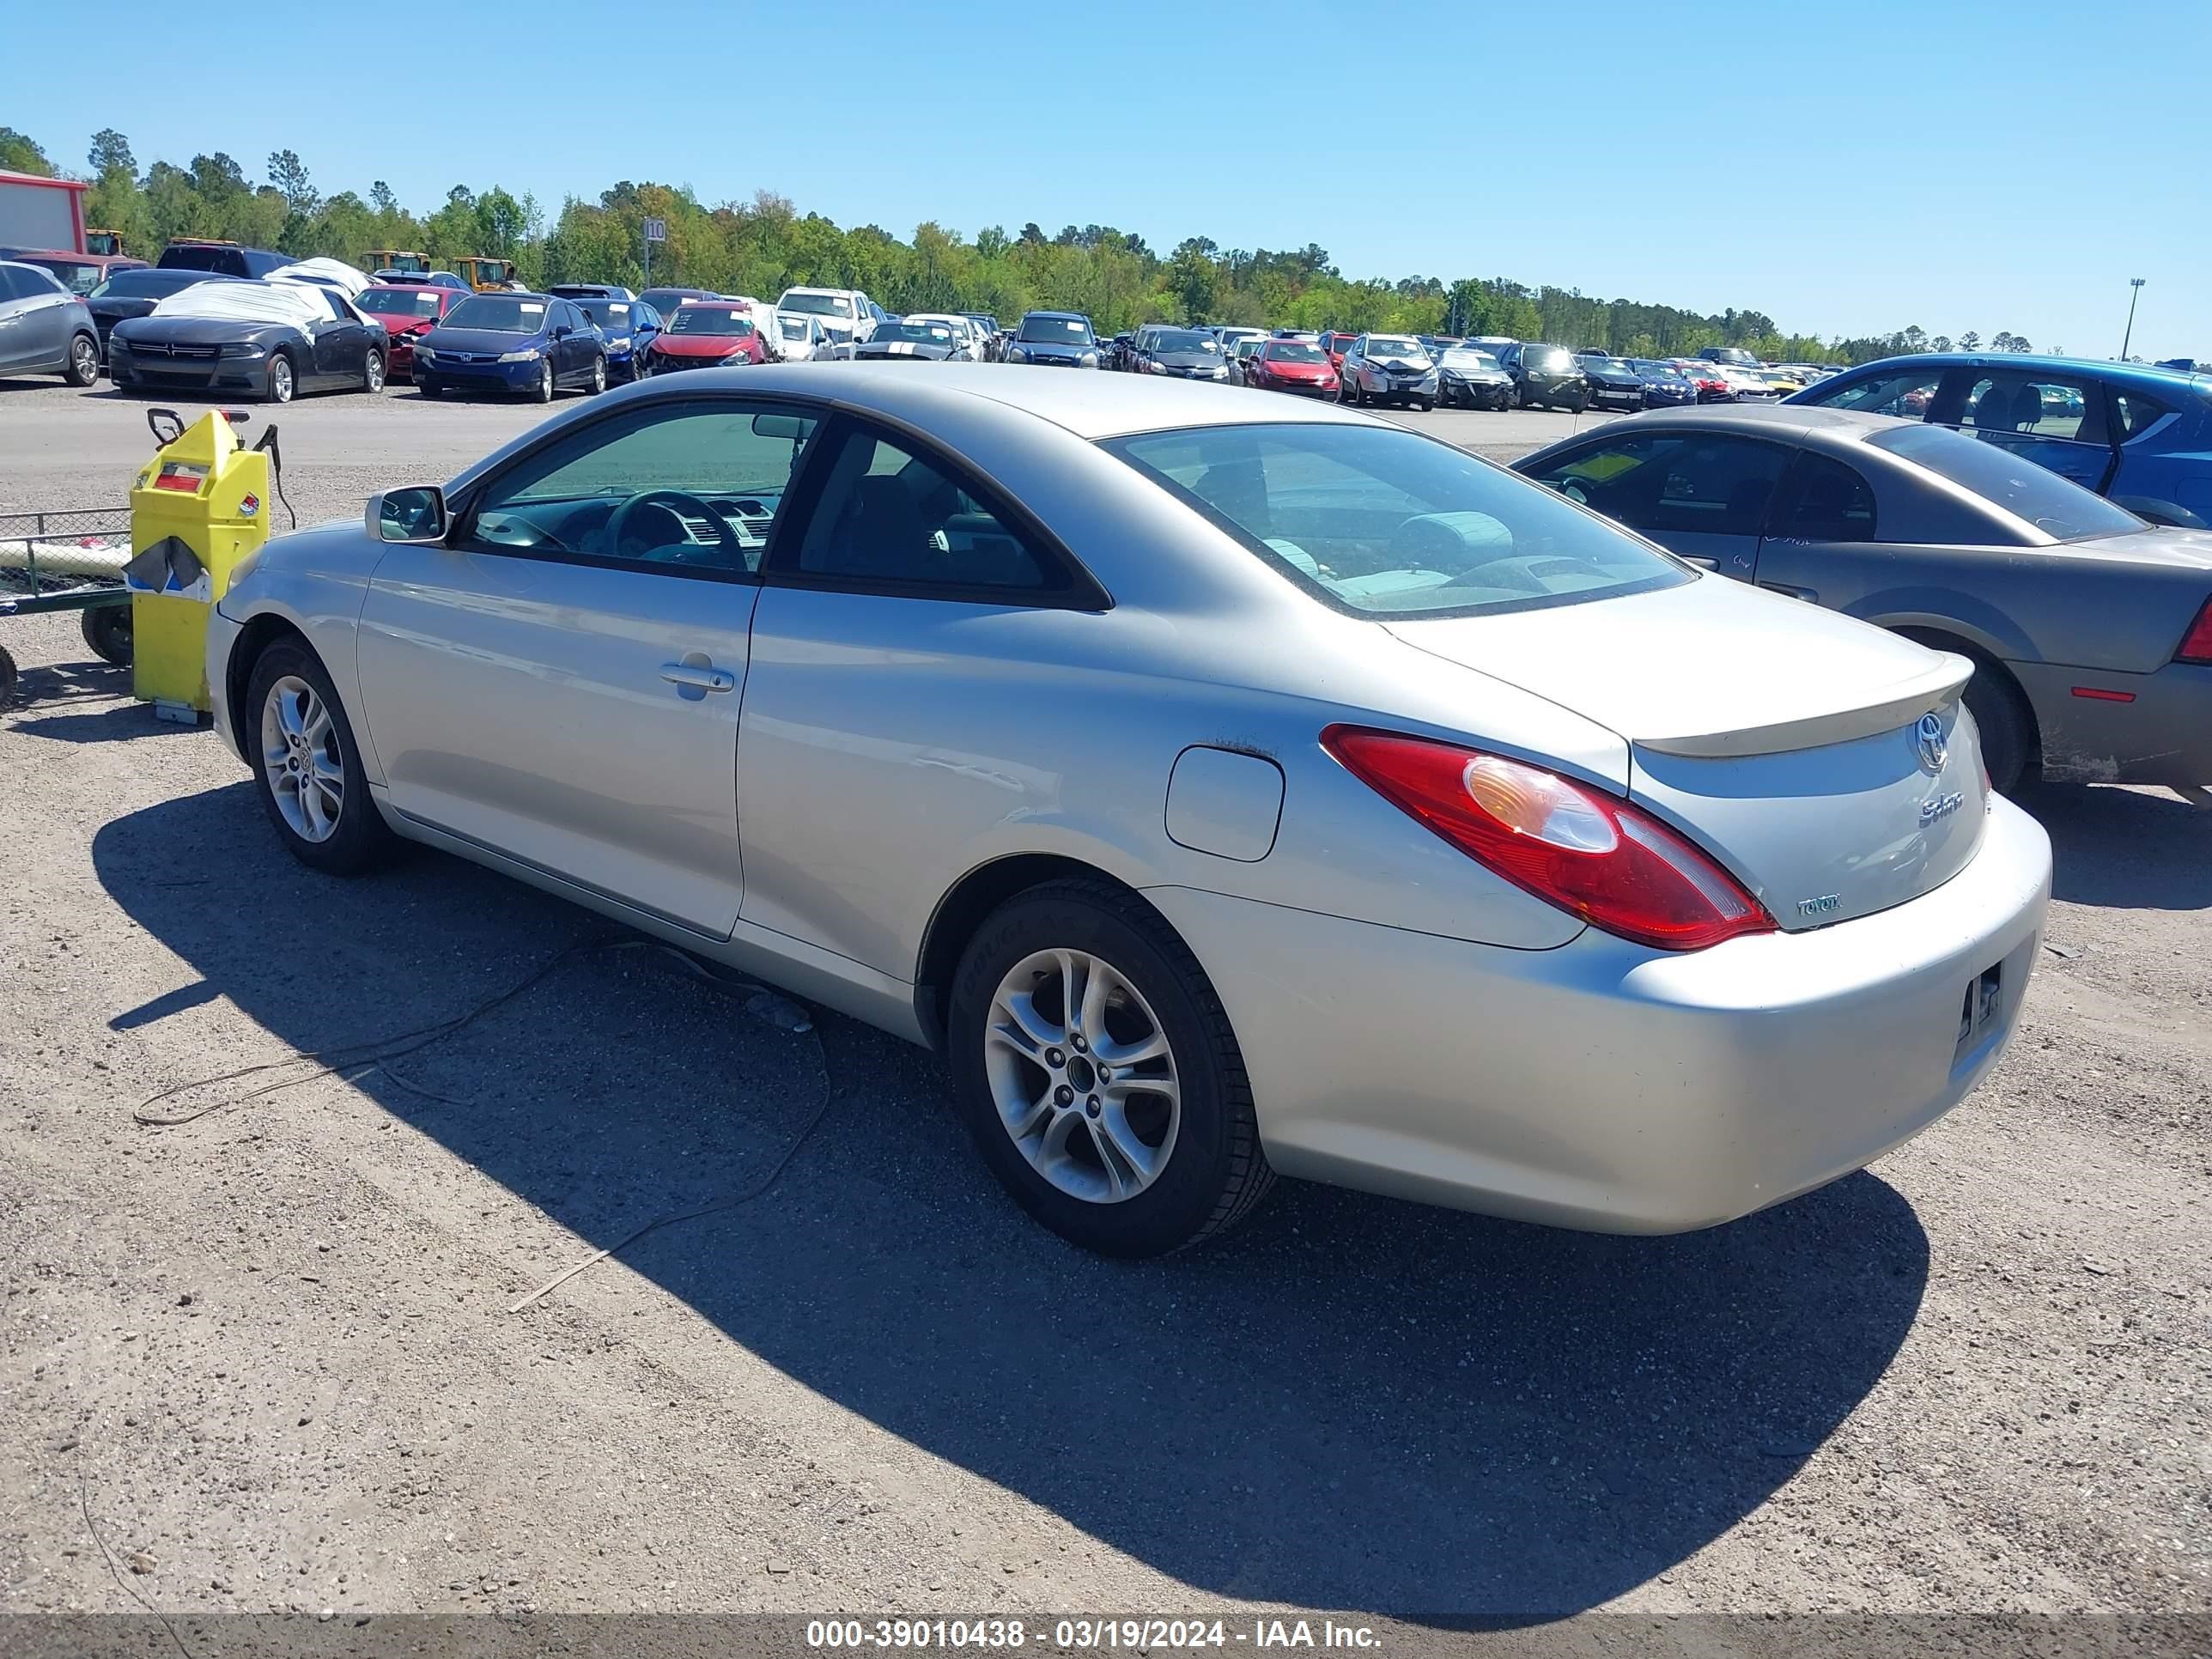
left=1321, top=726, right=1774, bottom=951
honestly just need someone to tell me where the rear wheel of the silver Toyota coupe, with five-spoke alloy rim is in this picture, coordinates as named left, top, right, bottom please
left=947, top=880, right=1274, bottom=1256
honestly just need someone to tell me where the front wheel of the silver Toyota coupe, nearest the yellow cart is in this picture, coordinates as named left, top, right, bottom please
left=239, top=639, right=396, bottom=876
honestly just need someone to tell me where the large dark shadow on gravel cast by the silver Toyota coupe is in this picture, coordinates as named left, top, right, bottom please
left=93, top=783, right=1929, bottom=1626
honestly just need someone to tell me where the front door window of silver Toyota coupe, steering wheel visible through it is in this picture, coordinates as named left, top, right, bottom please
left=462, top=398, right=818, bottom=580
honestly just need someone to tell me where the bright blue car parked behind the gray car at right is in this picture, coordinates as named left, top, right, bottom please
left=1783, top=352, right=2212, bottom=529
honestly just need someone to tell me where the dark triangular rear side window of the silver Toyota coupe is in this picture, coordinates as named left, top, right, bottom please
left=796, top=425, right=1068, bottom=598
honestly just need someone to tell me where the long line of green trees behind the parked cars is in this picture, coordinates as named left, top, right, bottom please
left=0, top=128, right=2028, bottom=362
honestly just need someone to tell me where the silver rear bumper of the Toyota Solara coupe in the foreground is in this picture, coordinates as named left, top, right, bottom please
left=1146, top=799, right=2051, bottom=1232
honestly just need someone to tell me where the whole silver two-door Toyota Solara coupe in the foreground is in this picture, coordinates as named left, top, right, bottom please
left=208, top=362, right=2051, bottom=1255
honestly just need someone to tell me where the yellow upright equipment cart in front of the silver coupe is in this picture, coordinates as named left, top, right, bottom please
left=124, top=410, right=276, bottom=723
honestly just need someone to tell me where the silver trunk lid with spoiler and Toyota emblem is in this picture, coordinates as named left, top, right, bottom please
left=1389, top=577, right=1986, bottom=931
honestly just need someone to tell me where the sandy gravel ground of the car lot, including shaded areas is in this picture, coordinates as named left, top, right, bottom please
left=0, top=375, right=2212, bottom=1624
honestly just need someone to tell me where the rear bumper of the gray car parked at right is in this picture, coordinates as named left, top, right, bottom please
left=2006, top=664, right=2212, bottom=785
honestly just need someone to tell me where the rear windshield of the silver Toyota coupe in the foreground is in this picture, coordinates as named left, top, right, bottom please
left=1102, top=422, right=1694, bottom=617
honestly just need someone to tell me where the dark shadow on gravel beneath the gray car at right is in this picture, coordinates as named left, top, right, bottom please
left=2021, top=783, right=2212, bottom=909
